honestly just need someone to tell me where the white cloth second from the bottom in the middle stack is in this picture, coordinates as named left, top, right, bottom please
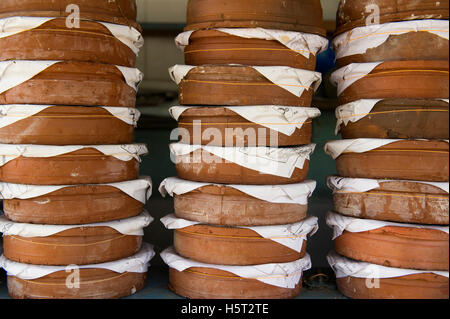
left=161, top=214, right=319, bottom=252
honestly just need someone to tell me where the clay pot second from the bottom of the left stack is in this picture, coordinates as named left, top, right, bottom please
left=3, top=227, right=142, bottom=266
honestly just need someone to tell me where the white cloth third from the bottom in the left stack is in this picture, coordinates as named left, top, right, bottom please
left=0, top=176, right=152, bottom=204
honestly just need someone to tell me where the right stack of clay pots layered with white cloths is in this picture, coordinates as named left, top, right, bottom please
left=325, top=0, right=449, bottom=299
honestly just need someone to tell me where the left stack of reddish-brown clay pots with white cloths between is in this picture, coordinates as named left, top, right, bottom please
left=0, top=0, right=154, bottom=299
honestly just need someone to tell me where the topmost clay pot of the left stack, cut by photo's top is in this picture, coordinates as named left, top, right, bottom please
left=0, top=0, right=140, bottom=28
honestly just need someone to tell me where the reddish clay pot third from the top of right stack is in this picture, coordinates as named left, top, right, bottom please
left=339, top=61, right=449, bottom=104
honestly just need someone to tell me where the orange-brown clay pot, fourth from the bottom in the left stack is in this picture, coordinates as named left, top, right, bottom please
left=0, top=148, right=139, bottom=185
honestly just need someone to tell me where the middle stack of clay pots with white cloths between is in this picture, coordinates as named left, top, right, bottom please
left=160, top=0, right=327, bottom=299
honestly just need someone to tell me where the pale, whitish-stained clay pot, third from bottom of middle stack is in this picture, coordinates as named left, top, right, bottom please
left=174, top=185, right=308, bottom=226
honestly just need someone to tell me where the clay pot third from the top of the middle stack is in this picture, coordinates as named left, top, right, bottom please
left=178, top=66, right=314, bottom=107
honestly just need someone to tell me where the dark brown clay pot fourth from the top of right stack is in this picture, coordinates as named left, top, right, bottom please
left=341, top=99, right=449, bottom=139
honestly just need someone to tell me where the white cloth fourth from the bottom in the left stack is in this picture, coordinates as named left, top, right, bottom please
left=0, top=144, right=148, bottom=166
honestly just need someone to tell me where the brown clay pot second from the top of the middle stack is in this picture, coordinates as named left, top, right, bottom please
left=184, top=30, right=316, bottom=71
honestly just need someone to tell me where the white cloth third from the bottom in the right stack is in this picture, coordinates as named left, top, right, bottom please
left=327, top=176, right=449, bottom=193
